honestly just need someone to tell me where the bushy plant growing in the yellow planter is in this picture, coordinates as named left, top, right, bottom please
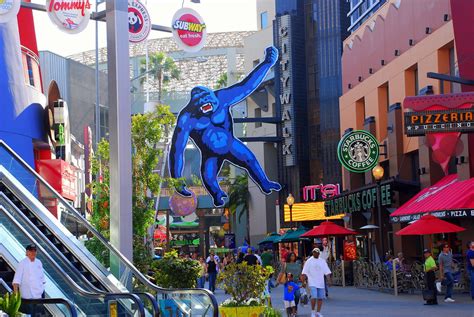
left=217, top=262, right=269, bottom=306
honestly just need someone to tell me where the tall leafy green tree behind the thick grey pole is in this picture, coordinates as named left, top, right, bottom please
left=86, top=105, right=175, bottom=272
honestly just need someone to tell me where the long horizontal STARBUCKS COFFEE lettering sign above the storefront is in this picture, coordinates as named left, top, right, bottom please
left=324, top=184, right=392, bottom=217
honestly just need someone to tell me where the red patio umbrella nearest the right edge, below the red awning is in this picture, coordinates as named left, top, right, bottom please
left=396, top=215, right=466, bottom=236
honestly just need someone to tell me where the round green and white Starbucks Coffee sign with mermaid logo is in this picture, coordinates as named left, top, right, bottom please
left=337, top=130, right=379, bottom=173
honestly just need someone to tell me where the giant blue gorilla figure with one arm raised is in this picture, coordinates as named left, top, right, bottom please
left=169, top=46, right=281, bottom=207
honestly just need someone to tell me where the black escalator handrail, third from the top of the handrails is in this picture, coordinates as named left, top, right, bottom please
left=0, top=206, right=145, bottom=317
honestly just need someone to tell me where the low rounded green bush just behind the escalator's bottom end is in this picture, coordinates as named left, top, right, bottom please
left=152, top=250, right=201, bottom=288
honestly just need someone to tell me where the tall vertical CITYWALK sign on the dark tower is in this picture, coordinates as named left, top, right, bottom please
left=278, top=15, right=296, bottom=166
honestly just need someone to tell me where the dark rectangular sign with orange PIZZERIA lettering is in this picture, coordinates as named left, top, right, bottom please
left=405, top=108, right=474, bottom=136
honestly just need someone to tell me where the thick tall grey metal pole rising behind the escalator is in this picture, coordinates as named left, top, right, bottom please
left=106, top=0, right=133, bottom=277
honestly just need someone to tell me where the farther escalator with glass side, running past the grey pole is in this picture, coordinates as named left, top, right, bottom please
left=0, top=140, right=218, bottom=316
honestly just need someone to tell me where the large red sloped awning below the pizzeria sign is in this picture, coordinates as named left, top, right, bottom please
left=390, top=174, right=474, bottom=222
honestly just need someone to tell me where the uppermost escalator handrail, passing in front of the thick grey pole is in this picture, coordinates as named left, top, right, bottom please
left=0, top=140, right=219, bottom=317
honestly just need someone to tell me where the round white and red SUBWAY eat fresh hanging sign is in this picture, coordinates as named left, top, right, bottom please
left=171, top=8, right=207, bottom=52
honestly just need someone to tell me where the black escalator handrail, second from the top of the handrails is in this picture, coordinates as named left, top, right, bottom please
left=0, top=192, right=159, bottom=316
